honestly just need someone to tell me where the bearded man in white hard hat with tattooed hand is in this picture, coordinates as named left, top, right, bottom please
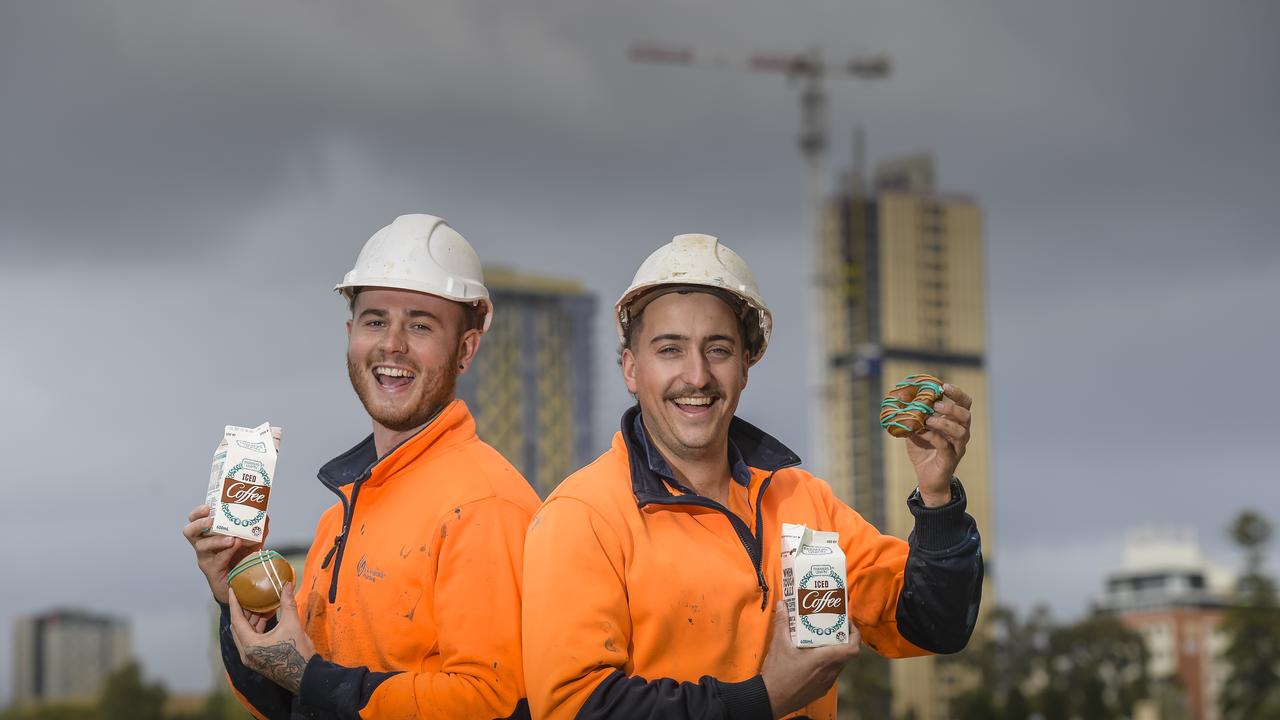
left=184, top=215, right=538, bottom=719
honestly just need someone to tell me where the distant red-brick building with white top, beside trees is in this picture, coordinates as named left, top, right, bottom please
left=1096, top=528, right=1230, bottom=720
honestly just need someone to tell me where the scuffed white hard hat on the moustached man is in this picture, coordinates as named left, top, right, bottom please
left=613, top=233, right=773, bottom=365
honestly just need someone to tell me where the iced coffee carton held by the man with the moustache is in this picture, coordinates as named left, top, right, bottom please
left=782, top=523, right=849, bottom=647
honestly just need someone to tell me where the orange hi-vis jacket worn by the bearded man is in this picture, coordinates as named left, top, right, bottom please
left=221, top=400, right=539, bottom=720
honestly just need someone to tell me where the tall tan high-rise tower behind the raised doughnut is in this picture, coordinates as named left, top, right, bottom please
left=819, top=155, right=995, bottom=720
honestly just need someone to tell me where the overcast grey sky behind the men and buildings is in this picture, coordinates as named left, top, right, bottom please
left=0, top=0, right=1280, bottom=698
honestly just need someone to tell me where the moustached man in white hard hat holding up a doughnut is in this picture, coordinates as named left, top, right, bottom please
left=524, top=234, right=983, bottom=720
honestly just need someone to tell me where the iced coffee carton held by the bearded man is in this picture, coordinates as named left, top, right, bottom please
left=205, top=423, right=280, bottom=542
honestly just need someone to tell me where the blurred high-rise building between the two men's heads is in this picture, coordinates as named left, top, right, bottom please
left=458, top=268, right=598, bottom=497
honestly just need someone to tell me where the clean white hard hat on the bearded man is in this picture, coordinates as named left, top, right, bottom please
left=334, top=215, right=493, bottom=332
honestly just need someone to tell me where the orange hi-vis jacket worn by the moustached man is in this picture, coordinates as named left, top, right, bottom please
left=524, top=407, right=983, bottom=720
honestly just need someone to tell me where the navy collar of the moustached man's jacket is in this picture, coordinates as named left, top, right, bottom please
left=622, top=405, right=800, bottom=505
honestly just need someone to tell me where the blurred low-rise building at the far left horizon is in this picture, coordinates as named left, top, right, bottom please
left=13, top=609, right=132, bottom=706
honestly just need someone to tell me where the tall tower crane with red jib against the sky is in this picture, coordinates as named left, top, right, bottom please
left=630, top=45, right=891, bottom=471
